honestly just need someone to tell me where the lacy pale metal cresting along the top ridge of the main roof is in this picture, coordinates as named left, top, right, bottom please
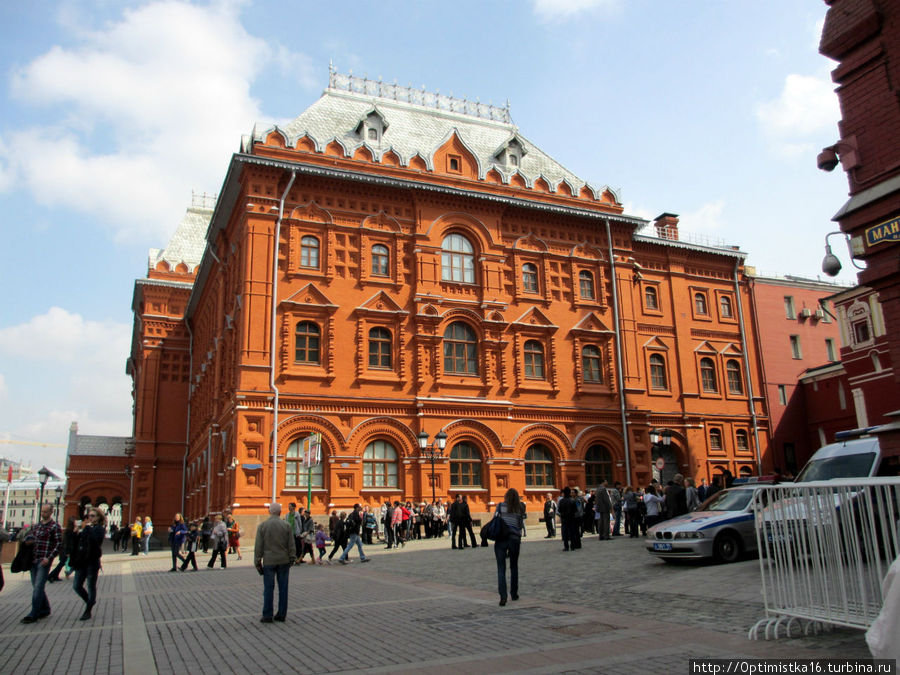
left=328, top=65, right=513, bottom=124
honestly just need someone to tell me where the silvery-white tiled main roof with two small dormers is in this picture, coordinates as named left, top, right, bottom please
left=253, top=73, right=618, bottom=197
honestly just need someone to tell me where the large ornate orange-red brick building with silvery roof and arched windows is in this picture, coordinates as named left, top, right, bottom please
left=67, top=73, right=768, bottom=527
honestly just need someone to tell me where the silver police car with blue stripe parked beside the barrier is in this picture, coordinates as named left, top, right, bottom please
left=645, top=484, right=757, bottom=562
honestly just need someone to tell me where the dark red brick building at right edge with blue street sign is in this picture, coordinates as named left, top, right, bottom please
left=818, top=0, right=900, bottom=454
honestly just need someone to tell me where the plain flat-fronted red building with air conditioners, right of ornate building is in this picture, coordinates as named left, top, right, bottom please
left=748, top=273, right=841, bottom=473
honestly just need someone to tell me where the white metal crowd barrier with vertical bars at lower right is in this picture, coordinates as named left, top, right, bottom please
left=749, top=478, right=900, bottom=640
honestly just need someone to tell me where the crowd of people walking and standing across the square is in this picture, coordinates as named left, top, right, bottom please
left=7, top=474, right=730, bottom=623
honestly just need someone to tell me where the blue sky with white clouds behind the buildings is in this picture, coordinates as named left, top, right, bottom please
left=0, top=0, right=854, bottom=476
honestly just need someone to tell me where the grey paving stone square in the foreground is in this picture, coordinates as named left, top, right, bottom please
left=0, top=537, right=869, bottom=675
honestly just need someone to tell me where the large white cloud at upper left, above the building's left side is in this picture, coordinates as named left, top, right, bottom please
left=0, top=1, right=314, bottom=243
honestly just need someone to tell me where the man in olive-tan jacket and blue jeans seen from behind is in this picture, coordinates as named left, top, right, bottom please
left=253, top=504, right=297, bottom=623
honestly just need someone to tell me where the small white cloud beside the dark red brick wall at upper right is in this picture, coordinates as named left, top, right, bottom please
left=756, top=74, right=840, bottom=156
